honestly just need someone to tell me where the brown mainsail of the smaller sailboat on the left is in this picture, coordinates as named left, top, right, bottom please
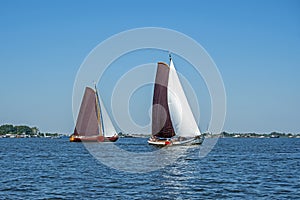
left=74, top=87, right=101, bottom=136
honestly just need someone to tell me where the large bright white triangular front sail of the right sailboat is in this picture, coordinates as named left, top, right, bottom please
left=168, top=60, right=201, bottom=137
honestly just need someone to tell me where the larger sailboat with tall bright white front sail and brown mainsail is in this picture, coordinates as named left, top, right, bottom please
left=148, top=56, right=204, bottom=146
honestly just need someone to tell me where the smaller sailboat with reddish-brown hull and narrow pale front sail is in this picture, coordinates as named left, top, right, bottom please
left=70, top=86, right=119, bottom=142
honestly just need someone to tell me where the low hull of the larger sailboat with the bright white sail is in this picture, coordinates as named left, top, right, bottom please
left=148, top=136, right=204, bottom=146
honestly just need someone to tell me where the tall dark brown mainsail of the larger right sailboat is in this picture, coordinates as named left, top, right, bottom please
left=152, top=62, right=175, bottom=138
